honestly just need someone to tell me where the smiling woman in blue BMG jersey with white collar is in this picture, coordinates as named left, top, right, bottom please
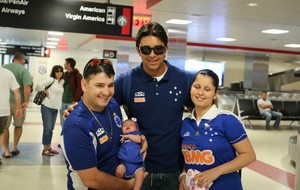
left=179, top=69, right=256, bottom=190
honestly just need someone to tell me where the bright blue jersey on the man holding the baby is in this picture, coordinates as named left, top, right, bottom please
left=61, top=99, right=122, bottom=189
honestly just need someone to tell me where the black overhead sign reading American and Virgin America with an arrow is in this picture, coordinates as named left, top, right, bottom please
left=0, top=0, right=133, bottom=37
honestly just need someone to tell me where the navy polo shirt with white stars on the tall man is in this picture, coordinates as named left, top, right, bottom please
left=114, top=61, right=193, bottom=173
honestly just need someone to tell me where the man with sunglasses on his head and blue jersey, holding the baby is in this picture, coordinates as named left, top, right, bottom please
left=61, top=59, right=134, bottom=190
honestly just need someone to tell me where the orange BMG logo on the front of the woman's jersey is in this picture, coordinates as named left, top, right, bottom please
left=182, top=144, right=215, bottom=165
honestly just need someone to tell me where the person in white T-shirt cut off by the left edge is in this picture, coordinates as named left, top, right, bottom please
left=0, top=67, right=23, bottom=165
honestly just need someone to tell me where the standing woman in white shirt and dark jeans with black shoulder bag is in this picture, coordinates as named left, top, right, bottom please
left=36, top=65, right=64, bottom=156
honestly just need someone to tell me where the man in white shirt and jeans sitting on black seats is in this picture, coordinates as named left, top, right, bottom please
left=257, top=91, right=282, bottom=130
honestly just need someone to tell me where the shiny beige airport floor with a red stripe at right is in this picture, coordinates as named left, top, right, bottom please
left=0, top=105, right=300, bottom=190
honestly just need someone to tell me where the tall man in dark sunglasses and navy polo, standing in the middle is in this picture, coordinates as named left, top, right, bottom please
left=114, top=23, right=192, bottom=190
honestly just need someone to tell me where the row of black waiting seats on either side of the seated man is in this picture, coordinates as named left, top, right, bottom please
left=236, top=98, right=300, bottom=128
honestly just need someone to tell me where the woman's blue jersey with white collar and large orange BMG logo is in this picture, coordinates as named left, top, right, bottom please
left=181, top=105, right=247, bottom=190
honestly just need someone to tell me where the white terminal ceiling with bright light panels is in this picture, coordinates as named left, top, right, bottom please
left=0, top=0, right=300, bottom=60
